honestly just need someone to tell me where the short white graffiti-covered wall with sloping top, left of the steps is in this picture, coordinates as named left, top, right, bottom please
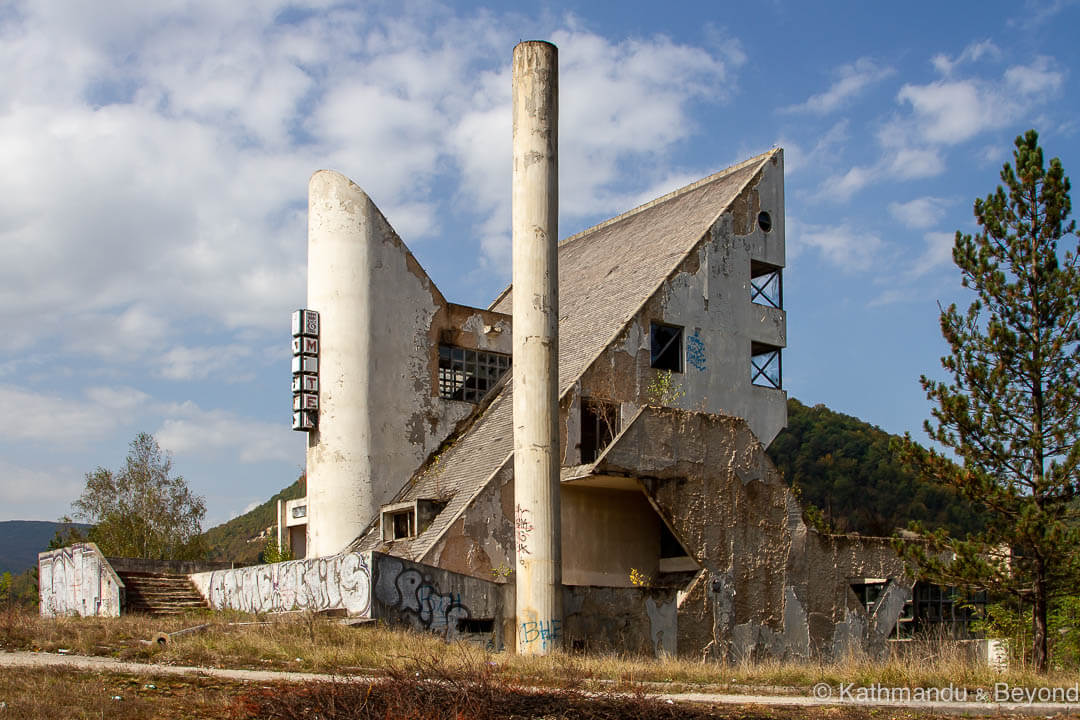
left=38, top=543, right=124, bottom=617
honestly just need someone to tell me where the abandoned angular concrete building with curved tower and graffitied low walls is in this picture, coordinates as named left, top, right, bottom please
left=40, top=43, right=963, bottom=660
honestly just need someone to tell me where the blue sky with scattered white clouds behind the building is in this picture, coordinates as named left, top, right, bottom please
left=0, top=0, right=1080, bottom=525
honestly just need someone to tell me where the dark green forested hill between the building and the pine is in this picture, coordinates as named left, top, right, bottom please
left=768, top=398, right=978, bottom=535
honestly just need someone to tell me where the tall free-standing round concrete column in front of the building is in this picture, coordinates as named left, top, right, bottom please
left=513, top=41, right=563, bottom=654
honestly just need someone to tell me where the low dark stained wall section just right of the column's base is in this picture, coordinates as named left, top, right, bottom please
left=565, top=585, right=678, bottom=657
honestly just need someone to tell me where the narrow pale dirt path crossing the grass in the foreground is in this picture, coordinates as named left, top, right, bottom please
left=0, top=652, right=1080, bottom=717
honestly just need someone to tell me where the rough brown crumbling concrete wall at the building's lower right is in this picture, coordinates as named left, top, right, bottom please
left=596, top=408, right=912, bottom=662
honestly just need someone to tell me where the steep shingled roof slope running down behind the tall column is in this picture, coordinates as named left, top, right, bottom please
left=353, top=150, right=778, bottom=560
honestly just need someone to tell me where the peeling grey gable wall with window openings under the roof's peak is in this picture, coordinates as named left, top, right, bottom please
left=574, top=153, right=787, bottom=465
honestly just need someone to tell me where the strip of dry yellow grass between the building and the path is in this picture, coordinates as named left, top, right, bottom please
left=0, top=609, right=1076, bottom=694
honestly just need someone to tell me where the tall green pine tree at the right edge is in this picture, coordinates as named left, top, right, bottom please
left=904, top=130, right=1080, bottom=671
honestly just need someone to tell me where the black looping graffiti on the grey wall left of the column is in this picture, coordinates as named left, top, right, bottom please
left=375, top=557, right=471, bottom=638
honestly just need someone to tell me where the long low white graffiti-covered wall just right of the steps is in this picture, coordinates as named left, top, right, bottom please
left=191, top=553, right=372, bottom=617
